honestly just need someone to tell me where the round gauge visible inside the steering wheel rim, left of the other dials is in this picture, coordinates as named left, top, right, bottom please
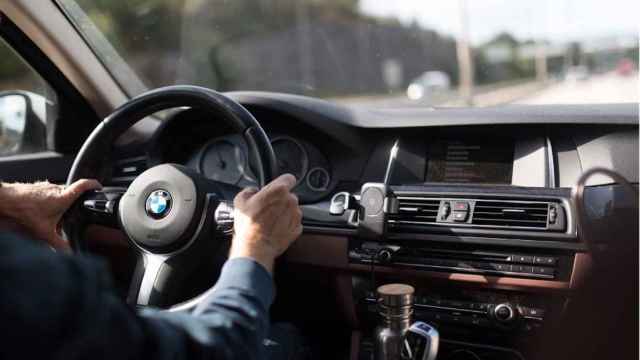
left=200, top=140, right=246, bottom=185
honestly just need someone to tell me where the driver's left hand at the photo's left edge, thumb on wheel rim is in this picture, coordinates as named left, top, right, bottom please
left=0, top=180, right=102, bottom=249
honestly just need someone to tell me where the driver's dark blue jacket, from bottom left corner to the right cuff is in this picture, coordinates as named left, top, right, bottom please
left=0, top=234, right=274, bottom=359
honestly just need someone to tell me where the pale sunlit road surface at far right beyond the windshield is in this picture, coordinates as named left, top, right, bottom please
left=514, top=72, right=640, bottom=104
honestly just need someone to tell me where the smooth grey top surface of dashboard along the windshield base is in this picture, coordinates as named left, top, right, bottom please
left=227, top=91, right=638, bottom=128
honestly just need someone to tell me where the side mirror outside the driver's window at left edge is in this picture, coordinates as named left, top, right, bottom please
left=0, top=91, right=47, bottom=156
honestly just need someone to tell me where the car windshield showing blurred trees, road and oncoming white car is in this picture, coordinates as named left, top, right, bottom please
left=59, top=0, right=640, bottom=108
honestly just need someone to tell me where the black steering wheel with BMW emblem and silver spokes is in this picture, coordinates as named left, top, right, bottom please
left=63, top=85, right=277, bottom=308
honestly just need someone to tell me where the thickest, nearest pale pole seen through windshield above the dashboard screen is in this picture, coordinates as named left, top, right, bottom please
left=456, top=0, right=473, bottom=106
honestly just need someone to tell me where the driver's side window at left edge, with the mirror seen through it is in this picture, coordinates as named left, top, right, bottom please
left=0, top=39, right=57, bottom=157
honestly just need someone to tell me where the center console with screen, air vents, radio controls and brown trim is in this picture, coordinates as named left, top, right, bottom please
left=331, top=139, right=584, bottom=359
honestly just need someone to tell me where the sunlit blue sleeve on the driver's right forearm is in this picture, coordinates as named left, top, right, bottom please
left=142, top=258, right=274, bottom=359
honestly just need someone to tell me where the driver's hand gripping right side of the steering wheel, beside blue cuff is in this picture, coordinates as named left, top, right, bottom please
left=229, top=174, right=302, bottom=272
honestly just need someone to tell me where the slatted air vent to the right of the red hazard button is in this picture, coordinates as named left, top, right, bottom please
left=471, top=200, right=549, bottom=229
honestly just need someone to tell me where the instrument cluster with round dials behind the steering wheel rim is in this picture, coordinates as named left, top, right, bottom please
left=141, top=110, right=334, bottom=203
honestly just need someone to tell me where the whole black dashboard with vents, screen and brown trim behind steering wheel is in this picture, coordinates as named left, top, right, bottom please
left=111, top=92, right=638, bottom=359
